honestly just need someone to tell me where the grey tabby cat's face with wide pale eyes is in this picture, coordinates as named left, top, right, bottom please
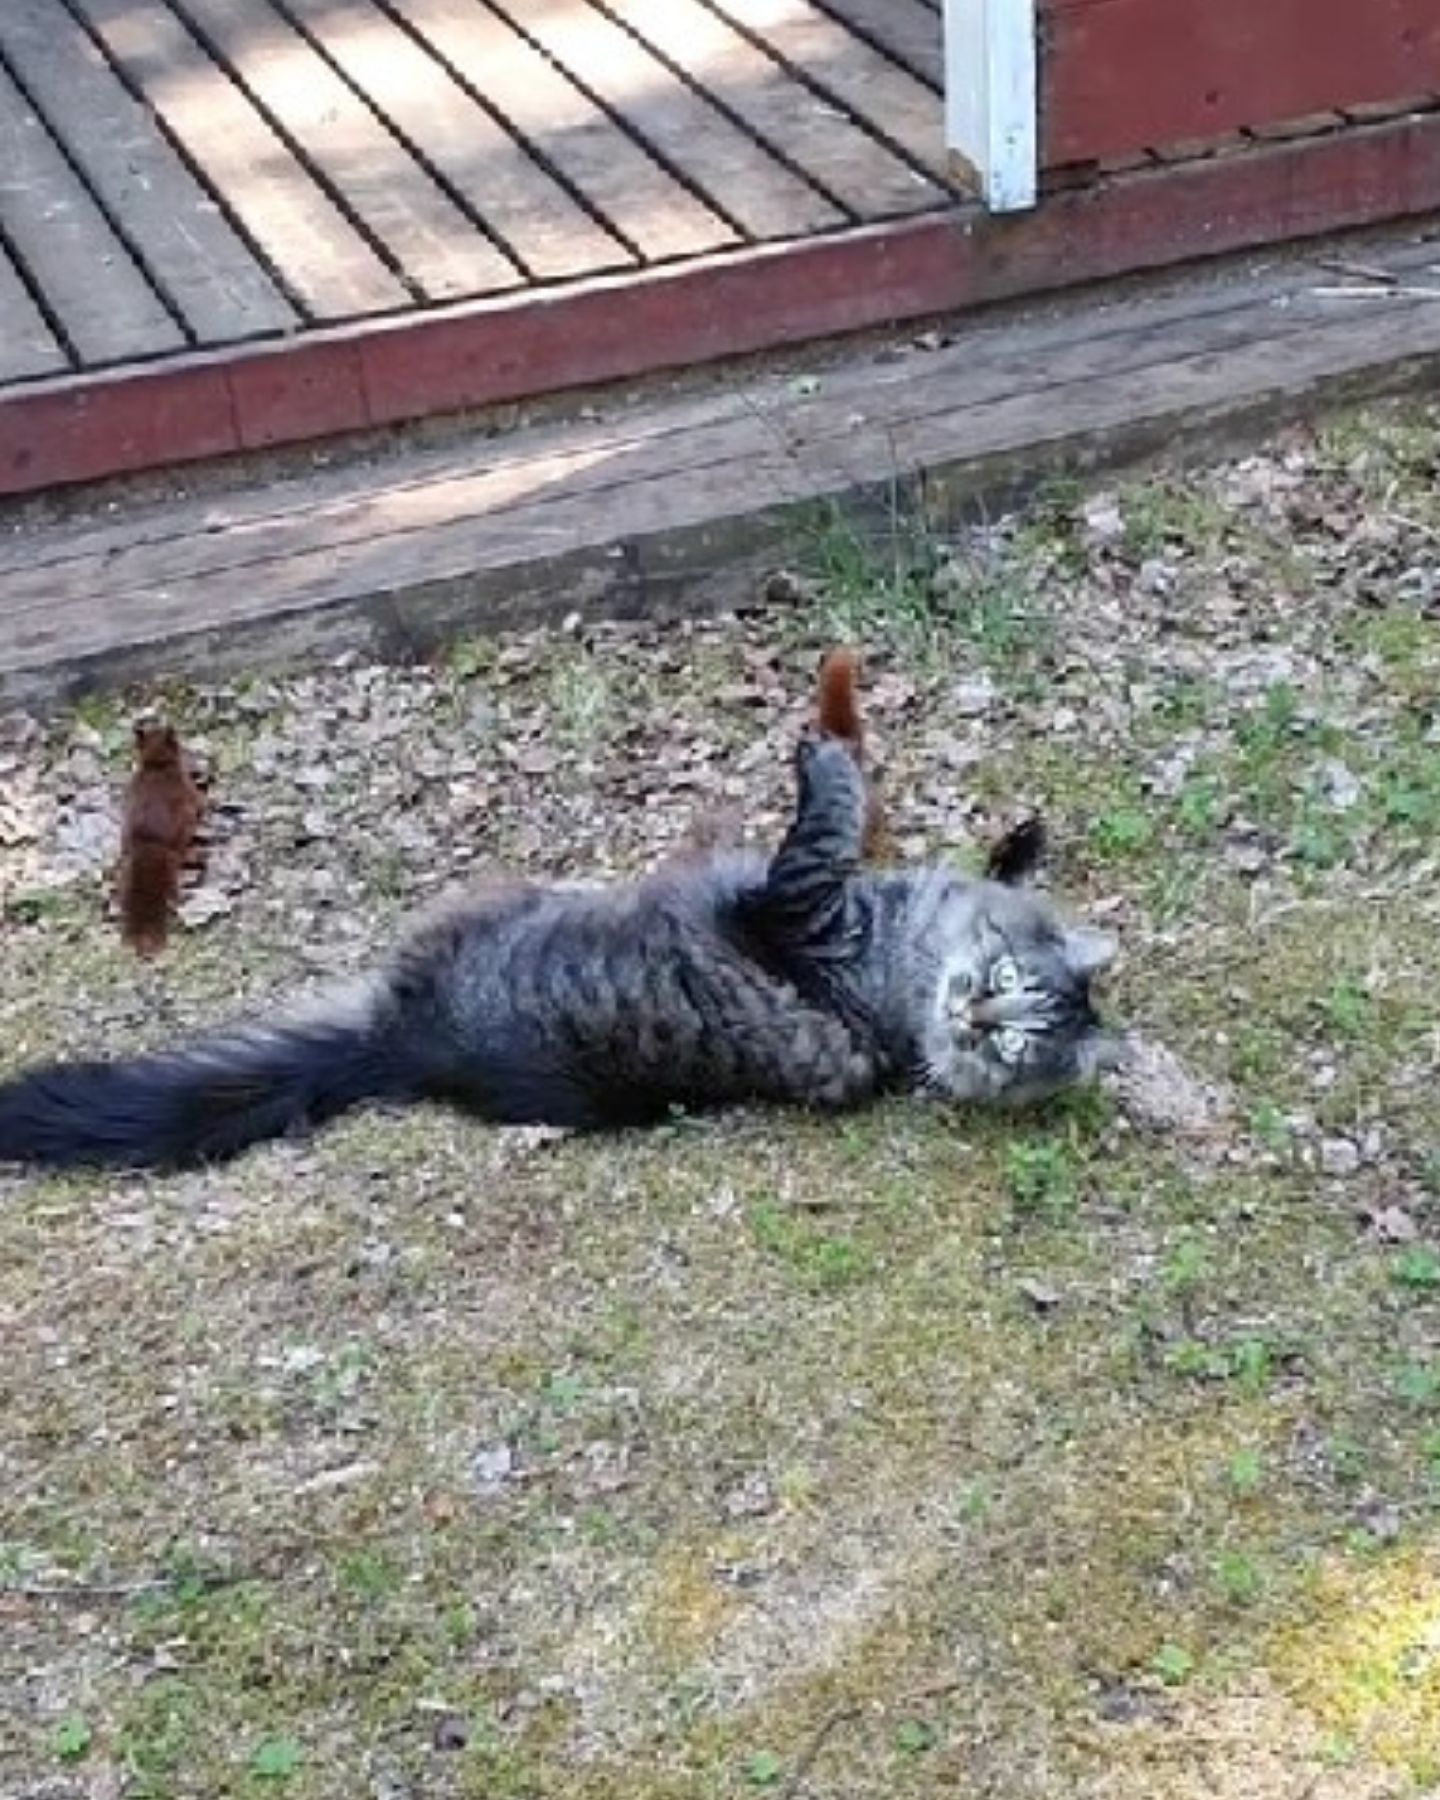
left=925, top=882, right=1121, bottom=1105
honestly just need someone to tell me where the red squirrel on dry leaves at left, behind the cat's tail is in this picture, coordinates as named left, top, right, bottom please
left=115, top=724, right=205, bottom=956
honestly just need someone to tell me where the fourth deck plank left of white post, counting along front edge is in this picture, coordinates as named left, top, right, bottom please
left=273, top=0, right=640, bottom=281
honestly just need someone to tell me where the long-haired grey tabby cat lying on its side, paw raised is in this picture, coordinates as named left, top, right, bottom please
left=0, top=734, right=1120, bottom=1168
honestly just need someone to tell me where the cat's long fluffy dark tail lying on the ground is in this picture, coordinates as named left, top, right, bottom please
left=0, top=999, right=428, bottom=1168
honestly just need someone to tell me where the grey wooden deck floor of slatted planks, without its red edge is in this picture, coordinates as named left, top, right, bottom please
left=0, top=0, right=954, bottom=385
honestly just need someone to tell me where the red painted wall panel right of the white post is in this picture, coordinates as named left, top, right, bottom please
left=1040, top=0, right=1440, bottom=167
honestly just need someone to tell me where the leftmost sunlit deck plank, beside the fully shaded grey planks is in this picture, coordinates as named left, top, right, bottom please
left=76, top=0, right=410, bottom=320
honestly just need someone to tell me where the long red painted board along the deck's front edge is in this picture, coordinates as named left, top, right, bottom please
left=0, top=113, right=1440, bottom=493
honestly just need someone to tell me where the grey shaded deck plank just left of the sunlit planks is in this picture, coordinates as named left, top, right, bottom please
left=0, top=0, right=295, bottom=344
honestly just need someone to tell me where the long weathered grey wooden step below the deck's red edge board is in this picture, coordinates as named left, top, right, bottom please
left=0, top=241, right=1440, bottom=704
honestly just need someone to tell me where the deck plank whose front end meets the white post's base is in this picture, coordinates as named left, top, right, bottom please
left=608, top=0, right=943, bottom=218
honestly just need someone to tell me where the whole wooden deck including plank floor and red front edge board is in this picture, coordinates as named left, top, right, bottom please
left=0, top=0, right=1440, bottom=495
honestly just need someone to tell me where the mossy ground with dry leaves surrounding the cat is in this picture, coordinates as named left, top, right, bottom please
left=0, top=397, right=1440, bottom=1800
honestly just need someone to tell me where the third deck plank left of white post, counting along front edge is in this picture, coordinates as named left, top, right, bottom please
left=376, top=0, right=736, bottom=261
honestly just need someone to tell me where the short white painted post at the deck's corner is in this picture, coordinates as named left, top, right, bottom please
left=945, top=0, right=1039, bottom=212
